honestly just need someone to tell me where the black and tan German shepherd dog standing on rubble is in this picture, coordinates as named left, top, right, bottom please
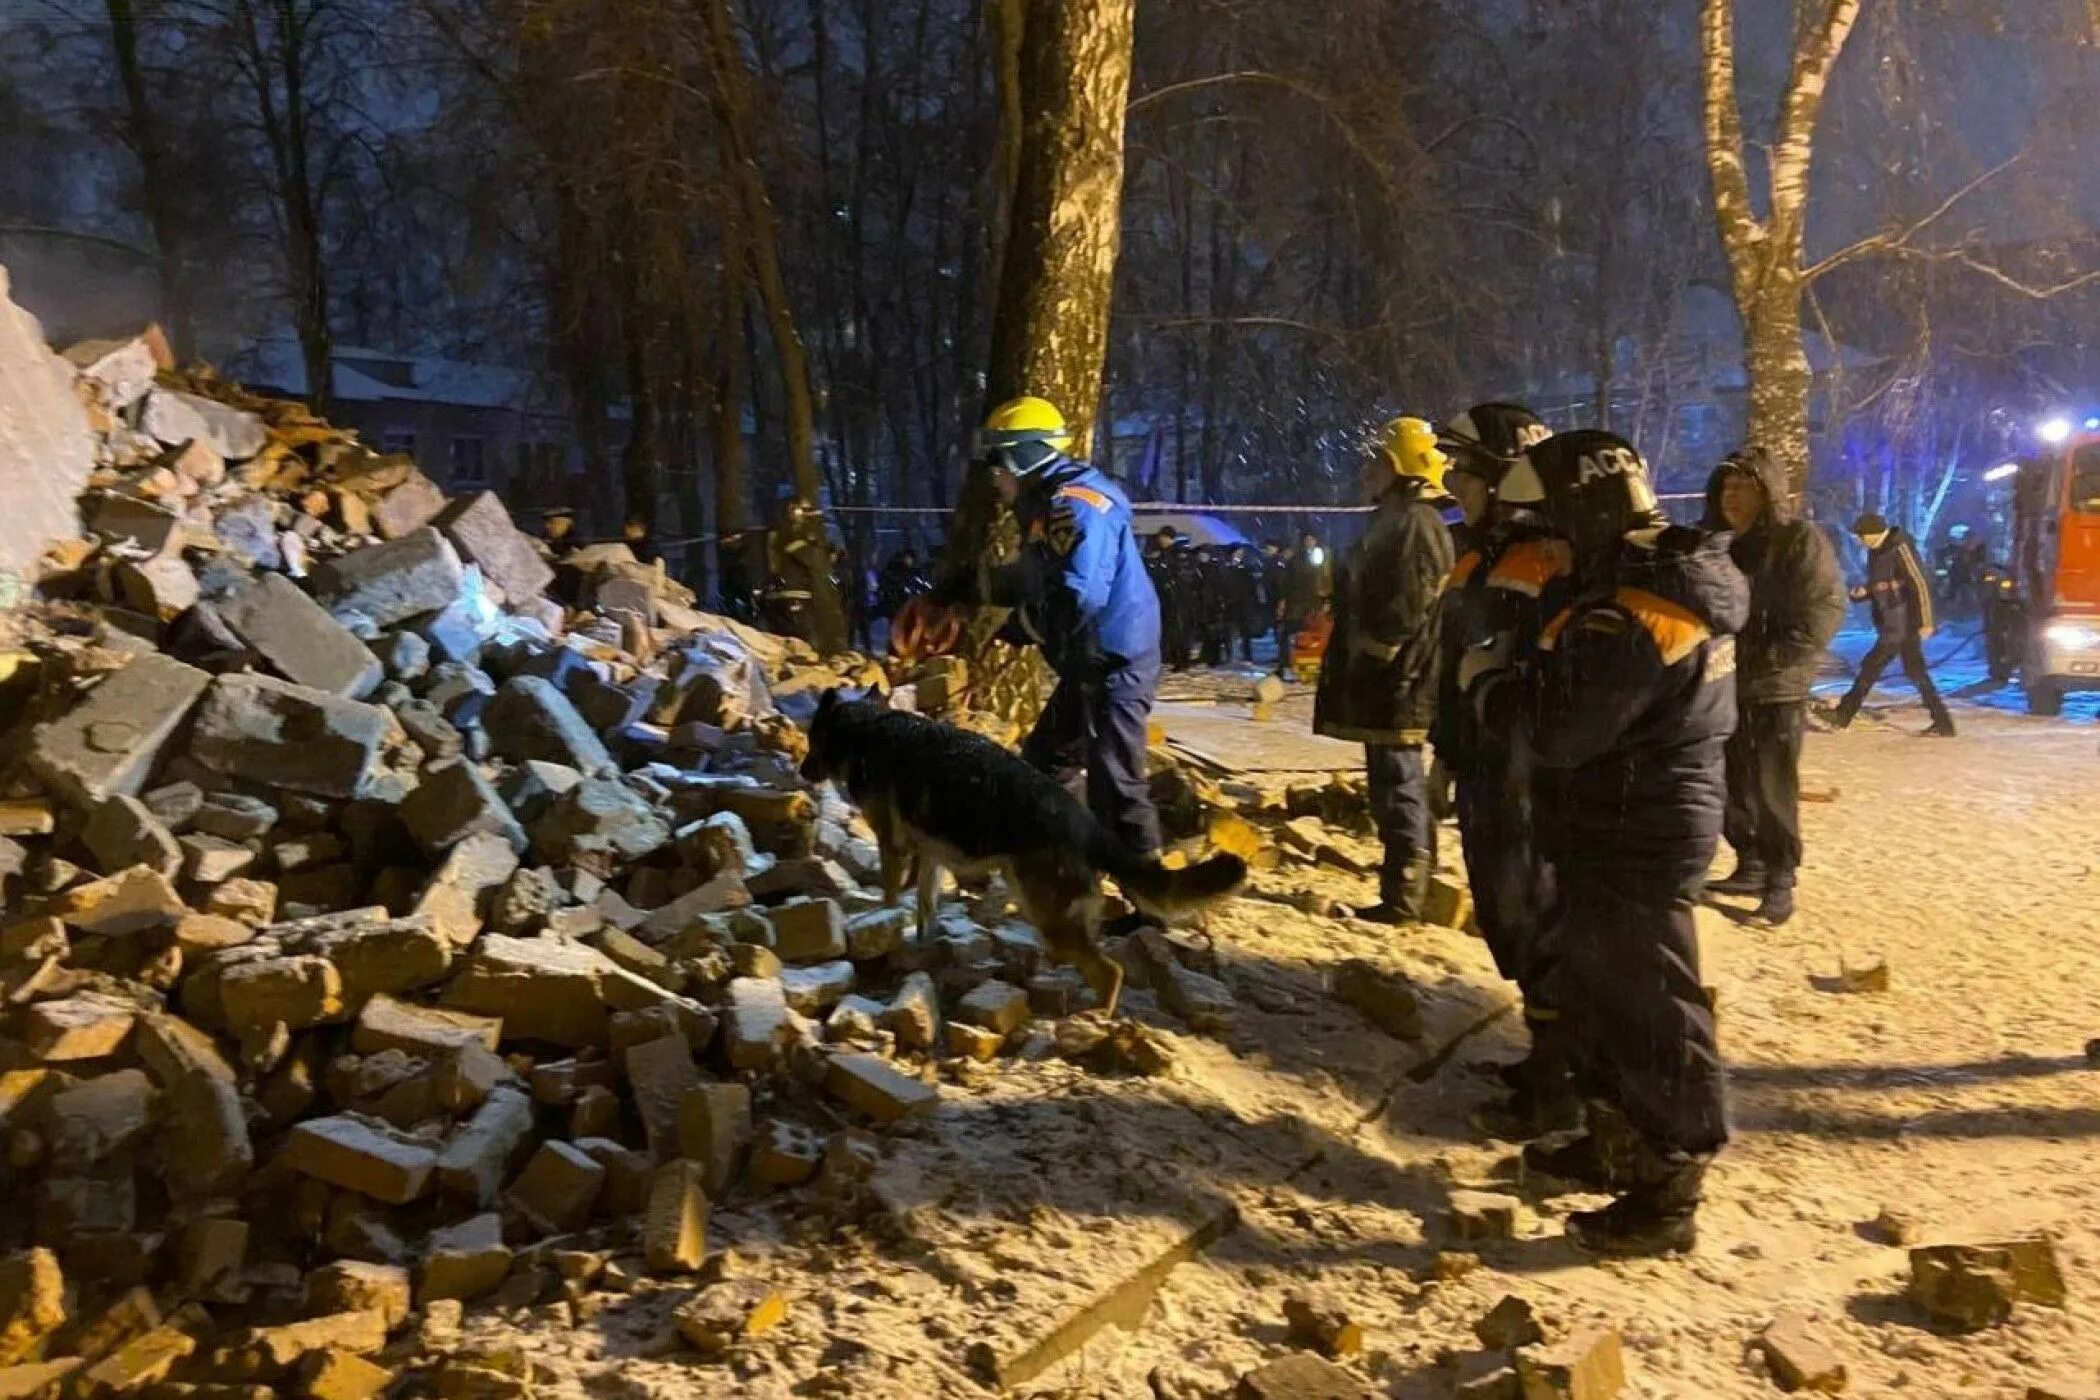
left=802, top=691, right=1247, bottom=1014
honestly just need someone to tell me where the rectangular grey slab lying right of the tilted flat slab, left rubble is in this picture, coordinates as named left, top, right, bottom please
left=189, top=674, right=401, bottom=798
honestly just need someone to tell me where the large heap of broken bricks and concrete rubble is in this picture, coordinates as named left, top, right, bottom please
left=0, top=321, right=1231, bottom=1396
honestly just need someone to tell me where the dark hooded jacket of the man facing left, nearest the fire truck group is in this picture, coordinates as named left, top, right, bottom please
left=1707, top=451, right=1846, bottom=705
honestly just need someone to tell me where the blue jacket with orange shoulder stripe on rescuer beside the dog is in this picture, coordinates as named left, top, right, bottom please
left=995, top=460, right=1159, bottom=676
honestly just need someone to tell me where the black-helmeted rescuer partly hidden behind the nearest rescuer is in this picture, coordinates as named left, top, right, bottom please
left=1430, top=403, right=1579, bottom=1138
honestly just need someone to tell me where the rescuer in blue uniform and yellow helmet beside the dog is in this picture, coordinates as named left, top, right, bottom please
left=979, top=397, right=1159, bottom=854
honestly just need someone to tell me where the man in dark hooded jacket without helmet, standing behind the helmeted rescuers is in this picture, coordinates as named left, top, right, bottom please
left=1705, top=447, right=1846, bottom=928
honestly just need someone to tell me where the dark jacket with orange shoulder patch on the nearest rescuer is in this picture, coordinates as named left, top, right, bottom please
left=1478, top=527, right=1749, bottom=898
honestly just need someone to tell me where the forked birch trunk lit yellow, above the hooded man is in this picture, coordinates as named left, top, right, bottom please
left=1703, top=0, right=1861, bottom=493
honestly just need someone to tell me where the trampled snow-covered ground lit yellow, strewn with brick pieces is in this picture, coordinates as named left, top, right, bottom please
left=479, top=638, right=2100, bottom=1400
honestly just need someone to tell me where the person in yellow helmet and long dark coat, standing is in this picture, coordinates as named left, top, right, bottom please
left=1313, top=418, right=1451, bottom=926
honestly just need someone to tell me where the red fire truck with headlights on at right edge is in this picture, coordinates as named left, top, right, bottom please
left=1985, top=430, right=2100, bottom=714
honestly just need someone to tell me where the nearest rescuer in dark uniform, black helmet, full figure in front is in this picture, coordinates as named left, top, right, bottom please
left=1468, top=430, right=1749, bottom=1255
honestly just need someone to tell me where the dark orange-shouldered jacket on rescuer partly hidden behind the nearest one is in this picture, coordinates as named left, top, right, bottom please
left=1430, top=525, right=1569, bottom=777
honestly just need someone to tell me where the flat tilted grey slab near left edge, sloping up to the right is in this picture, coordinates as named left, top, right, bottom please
left=29, top=653, right=212, bottom=810
